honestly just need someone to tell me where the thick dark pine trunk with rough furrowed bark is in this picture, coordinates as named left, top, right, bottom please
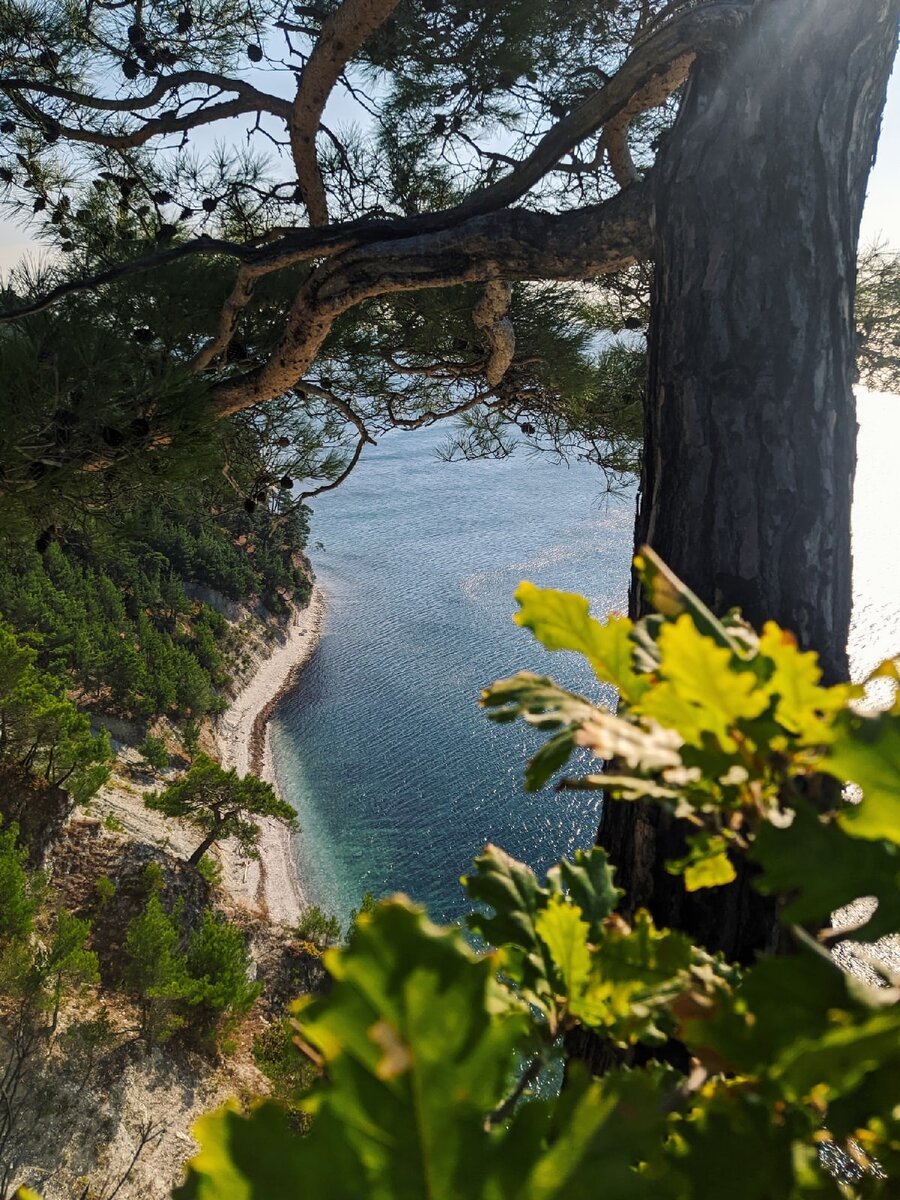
left=599, top=0, right=900, bottom=960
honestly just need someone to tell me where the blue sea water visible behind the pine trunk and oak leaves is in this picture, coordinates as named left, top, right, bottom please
left=271, top=392, right=900, bottom=922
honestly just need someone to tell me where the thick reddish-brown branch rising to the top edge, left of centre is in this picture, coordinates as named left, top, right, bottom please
left=289, top=0, right=398, bottom=226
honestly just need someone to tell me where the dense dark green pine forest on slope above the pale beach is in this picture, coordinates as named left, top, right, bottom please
left=0, top=502, right=308, bottom=720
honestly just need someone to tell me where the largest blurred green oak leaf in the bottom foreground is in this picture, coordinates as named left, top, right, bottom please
left=179, top=898, right=533, bottom=1200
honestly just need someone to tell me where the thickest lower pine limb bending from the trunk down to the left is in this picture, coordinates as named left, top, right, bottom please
left=212, top=182, right=652, bottom=416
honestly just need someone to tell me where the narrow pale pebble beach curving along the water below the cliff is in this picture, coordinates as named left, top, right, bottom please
left=216, top=584, right=325, bottom=924
